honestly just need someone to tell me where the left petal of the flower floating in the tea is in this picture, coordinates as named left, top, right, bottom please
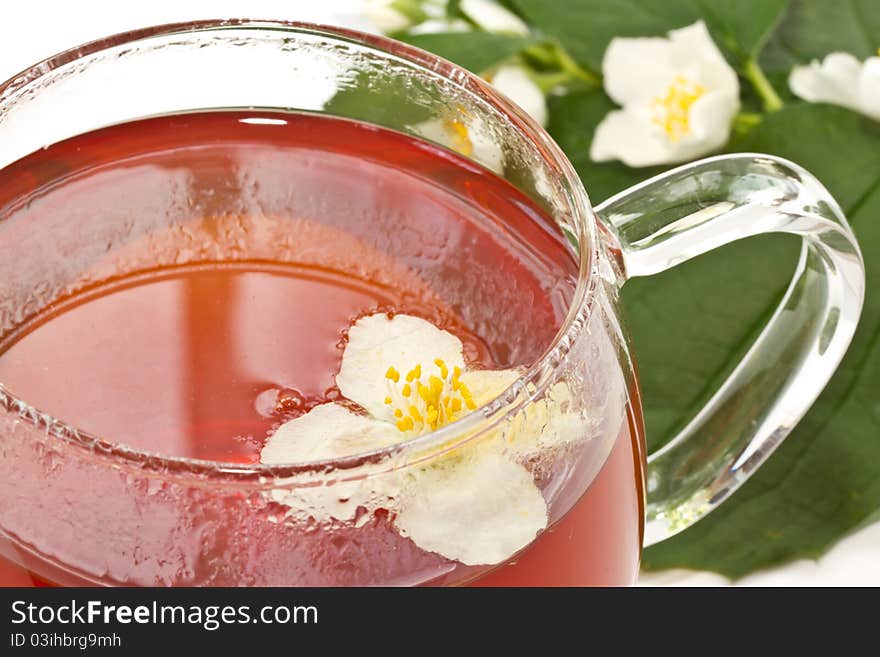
left=260, top=404, right=401, bottom=522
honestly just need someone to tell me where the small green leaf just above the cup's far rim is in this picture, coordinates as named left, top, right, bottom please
left=399, top=32, right=536, bottom=73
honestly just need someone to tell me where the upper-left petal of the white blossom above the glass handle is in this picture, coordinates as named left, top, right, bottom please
left=602, top=37, right=674, bottom=105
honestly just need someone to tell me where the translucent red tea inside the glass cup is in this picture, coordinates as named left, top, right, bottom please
left=0, top=112, right=643, bottom=585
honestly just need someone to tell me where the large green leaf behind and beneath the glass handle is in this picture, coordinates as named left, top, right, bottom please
left=640, top=104, right=880, bottom=577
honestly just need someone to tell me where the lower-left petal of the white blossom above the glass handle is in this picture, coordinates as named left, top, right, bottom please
left=590, top=110, right=673, bottom=167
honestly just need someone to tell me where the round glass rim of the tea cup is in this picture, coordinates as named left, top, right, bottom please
left=0, top=19, right=600, bottom=486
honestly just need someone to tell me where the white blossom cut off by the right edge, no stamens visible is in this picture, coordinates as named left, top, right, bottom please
left=788, top=51, right=880, bottom=121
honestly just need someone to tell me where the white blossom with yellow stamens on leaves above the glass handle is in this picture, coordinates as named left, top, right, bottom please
left=590, top=21, right=739, bottom=167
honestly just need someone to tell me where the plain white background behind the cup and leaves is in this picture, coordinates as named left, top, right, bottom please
left=0, top=0, right=880, bottom=586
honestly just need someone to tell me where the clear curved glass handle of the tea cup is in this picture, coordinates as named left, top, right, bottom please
left=596, top=154, right=865, bottom=545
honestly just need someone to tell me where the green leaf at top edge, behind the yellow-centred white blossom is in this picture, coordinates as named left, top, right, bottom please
left=512, top=0, right=788, bottom=72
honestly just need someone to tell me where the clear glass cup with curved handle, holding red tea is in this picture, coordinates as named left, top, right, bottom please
left=0, top=21, right=864, bottom=585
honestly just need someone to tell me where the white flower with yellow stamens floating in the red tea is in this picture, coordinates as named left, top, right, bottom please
left=261, top=314, right=584, bottom=565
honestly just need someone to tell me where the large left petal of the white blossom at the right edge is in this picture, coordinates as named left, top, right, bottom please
left=788, top=52, right=861, bottom=111
